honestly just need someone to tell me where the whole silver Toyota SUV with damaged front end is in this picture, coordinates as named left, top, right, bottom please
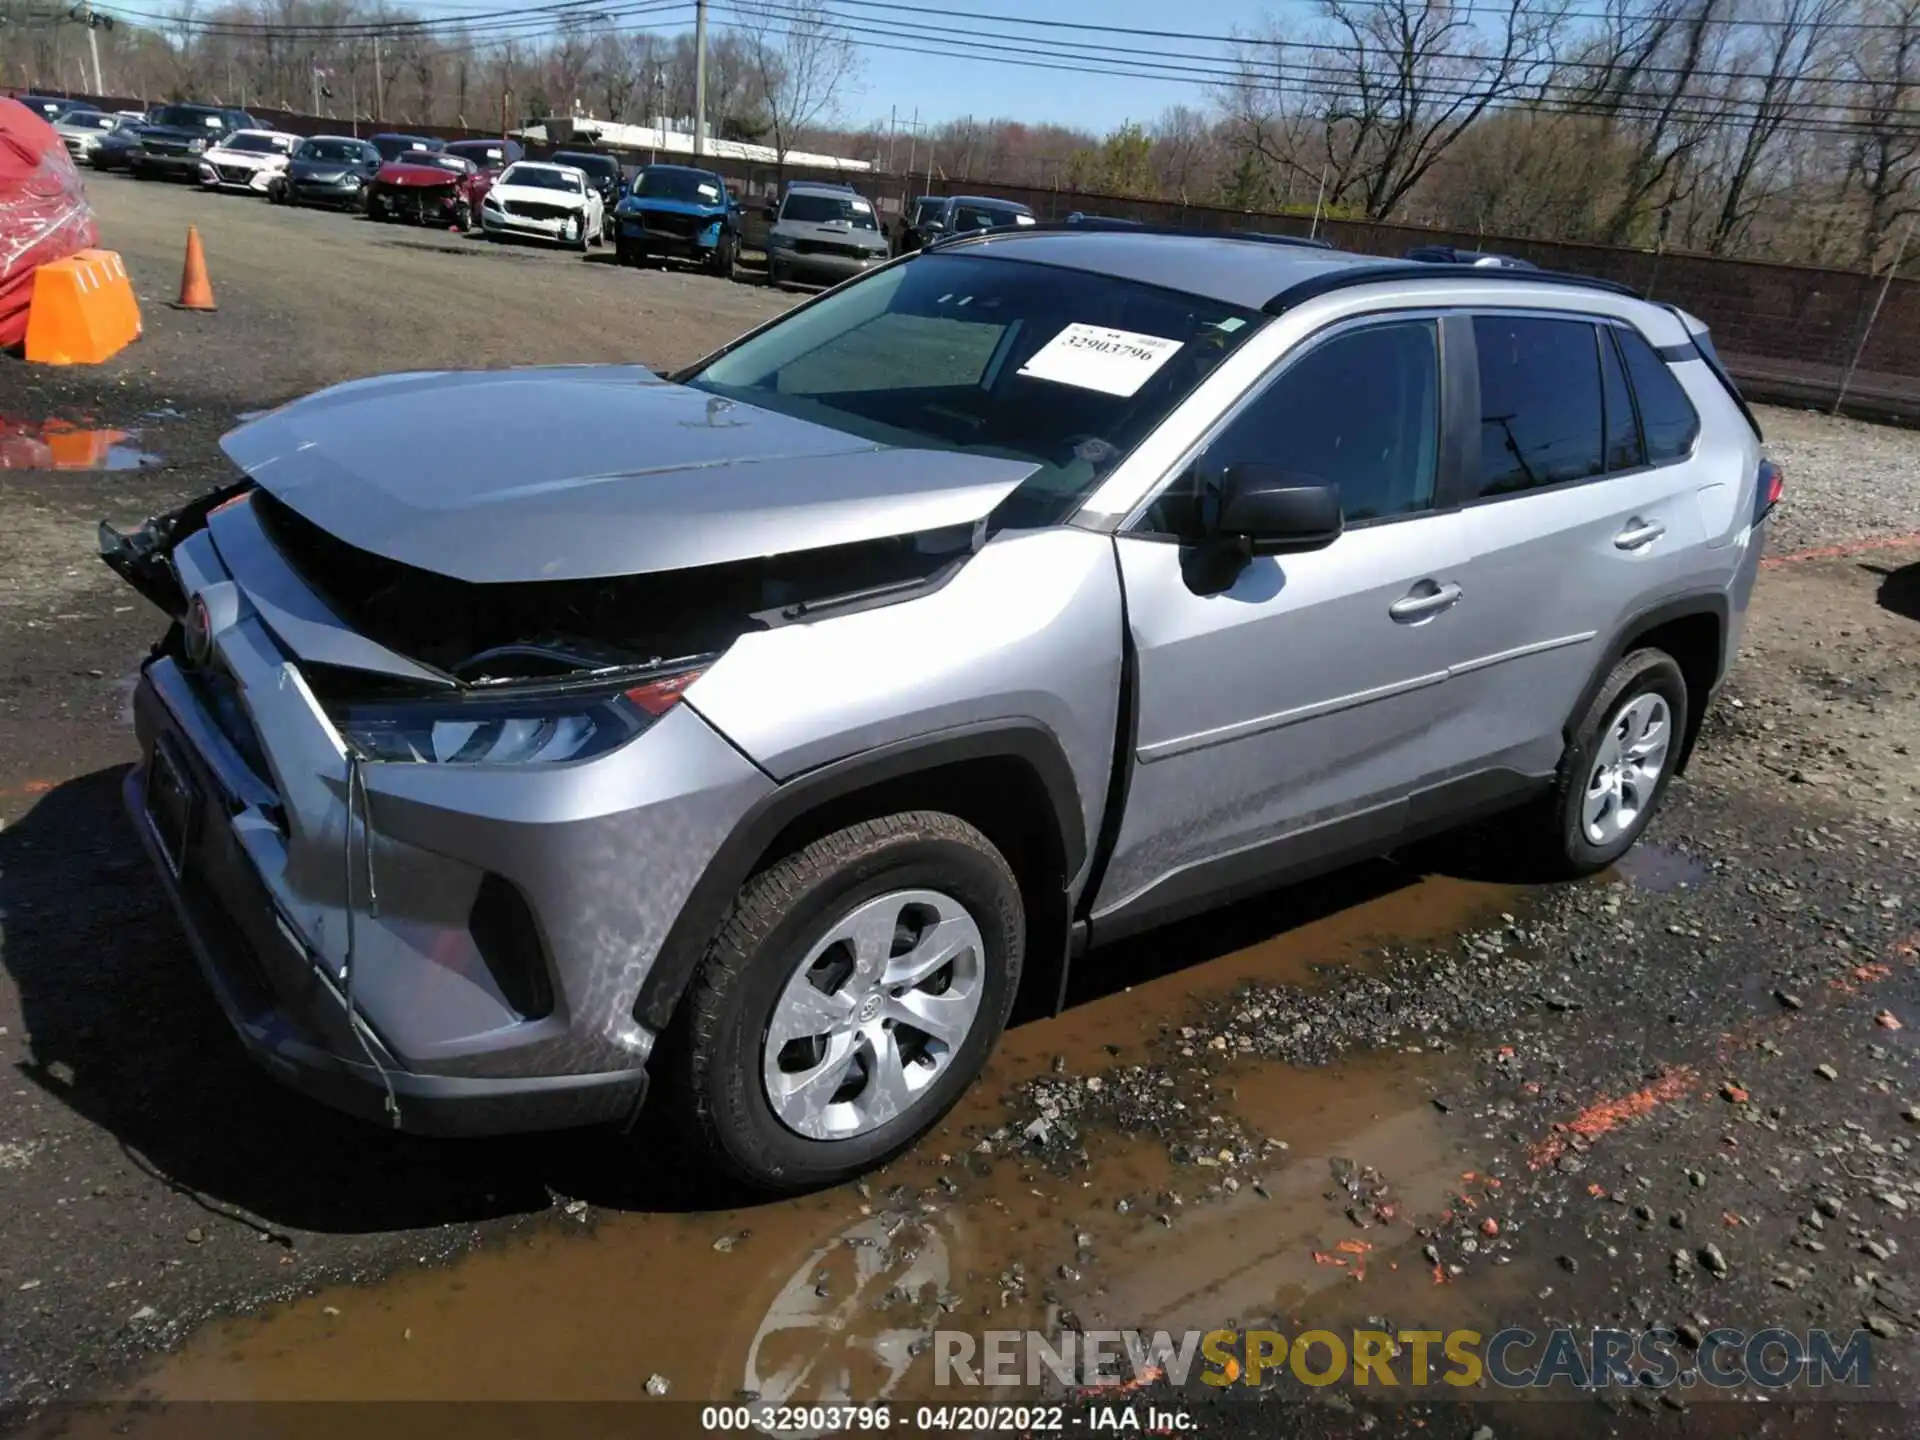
left=102, top=227, right=1780, bottom=1188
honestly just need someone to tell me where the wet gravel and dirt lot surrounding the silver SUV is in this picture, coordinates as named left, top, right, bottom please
left=0, top=171, right=1920, bottom=1440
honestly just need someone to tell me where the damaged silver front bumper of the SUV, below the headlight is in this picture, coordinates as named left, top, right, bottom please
left=127, top=505, right=772, bottom=1135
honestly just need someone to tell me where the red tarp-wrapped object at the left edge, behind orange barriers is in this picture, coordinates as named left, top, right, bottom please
left=0, top=96, right=100, bottom=349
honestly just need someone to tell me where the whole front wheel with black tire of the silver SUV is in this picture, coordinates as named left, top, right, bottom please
left=664, top=810, right=1025, bottom=1190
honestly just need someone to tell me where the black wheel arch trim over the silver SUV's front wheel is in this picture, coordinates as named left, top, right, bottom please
left=634, top=720, right=1087, bottom=1033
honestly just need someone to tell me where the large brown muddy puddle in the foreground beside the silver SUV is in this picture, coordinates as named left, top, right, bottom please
left=71, top=879, right=1517, bottom=1434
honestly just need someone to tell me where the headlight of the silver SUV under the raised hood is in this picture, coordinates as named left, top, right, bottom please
left=330, top=664, right=705, bottom=764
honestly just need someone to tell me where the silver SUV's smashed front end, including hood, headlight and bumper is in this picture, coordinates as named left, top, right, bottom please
left=100, top=367, right=1031, bottom=1133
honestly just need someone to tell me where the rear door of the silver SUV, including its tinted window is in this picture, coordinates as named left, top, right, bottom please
left=1455, top=311, right=1703, bottom=776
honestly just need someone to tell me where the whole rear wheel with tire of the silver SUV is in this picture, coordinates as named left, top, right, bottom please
left=1532, top=649, right=1692, bottom=879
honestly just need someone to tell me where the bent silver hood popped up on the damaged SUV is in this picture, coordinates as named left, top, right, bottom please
left=221, top=365, right=1035, bottom=584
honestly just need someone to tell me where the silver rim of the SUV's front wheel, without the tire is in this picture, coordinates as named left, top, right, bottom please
left=760, top=889, right=985, bottom=1140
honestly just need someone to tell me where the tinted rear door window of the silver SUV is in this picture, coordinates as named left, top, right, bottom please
left=1473, top=315, right=1607, bottom=495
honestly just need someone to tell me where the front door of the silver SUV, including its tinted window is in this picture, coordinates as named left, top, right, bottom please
left=1094, top=317, right=1475, bottom=933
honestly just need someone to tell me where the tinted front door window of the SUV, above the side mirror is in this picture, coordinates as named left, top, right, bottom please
left=1146, top=321, right=1440, bottom=536
